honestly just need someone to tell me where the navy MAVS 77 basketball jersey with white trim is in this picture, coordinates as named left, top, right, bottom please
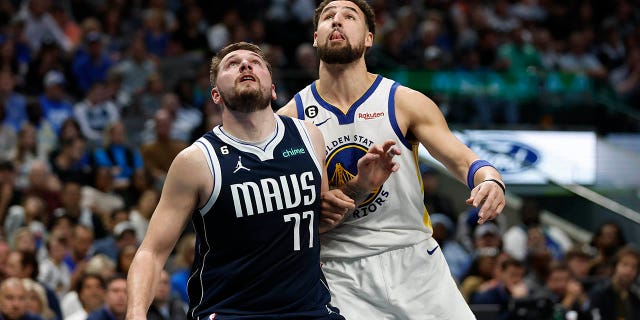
left=187, top=116, right=342, bottom=320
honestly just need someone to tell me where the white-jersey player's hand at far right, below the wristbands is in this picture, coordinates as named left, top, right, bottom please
left=466, top=181, right=506, bottom=224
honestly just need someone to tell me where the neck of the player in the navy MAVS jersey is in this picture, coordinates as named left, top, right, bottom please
left=222, top=107, right=276, bottom=142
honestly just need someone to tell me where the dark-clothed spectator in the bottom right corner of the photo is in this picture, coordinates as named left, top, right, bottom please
left=589, top=246, right=640, bottom=320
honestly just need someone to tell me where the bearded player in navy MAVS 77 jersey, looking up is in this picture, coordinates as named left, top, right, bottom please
left=127, top=42, right=398, bottom=320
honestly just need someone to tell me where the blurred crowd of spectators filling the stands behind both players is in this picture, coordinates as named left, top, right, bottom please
left=0, top=0, right=640, bottom=319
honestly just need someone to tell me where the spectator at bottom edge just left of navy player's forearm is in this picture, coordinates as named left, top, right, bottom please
left=87, top=275, right=127, bottom=320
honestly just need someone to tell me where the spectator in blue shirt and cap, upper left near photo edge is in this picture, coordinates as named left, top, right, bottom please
left=39, top=70, right=73, bottom=134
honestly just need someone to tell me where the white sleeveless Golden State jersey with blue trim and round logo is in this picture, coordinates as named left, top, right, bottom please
left=295, top=75, right=431, bottom=259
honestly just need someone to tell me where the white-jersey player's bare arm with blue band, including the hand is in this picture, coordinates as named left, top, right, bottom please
left=395, top=86, right=505, bottom=223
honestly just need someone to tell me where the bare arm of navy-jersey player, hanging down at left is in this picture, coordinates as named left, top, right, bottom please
left=122, top=146, right=208, bottom=320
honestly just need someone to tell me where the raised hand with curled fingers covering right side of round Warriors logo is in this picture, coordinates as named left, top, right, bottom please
left=351, top=140, right=400, bottom=192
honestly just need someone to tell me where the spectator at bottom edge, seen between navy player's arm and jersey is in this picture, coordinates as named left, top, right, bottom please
left=147, top=270, right=189, bottom=320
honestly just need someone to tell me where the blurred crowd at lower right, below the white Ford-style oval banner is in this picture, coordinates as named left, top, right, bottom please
left=421, top=165, right=640, bottom=320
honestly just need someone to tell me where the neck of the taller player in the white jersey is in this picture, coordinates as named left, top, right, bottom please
left=316, top=59, right=376, bottom=112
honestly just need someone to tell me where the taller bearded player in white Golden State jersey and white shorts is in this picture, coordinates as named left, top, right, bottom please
left=278, top=0, right=505, bottom=320
